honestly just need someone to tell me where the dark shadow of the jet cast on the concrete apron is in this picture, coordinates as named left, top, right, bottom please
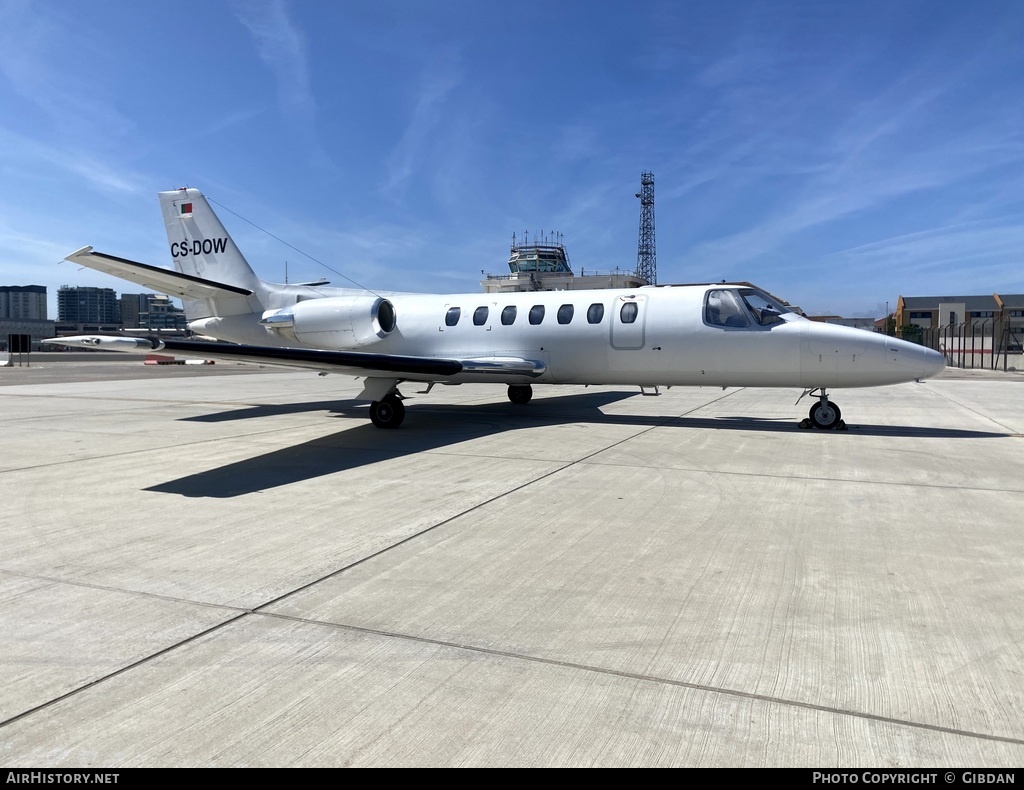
left=145, top=391, right=1010, bottom=498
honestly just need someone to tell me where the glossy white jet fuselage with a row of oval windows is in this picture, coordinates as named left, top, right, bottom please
left=194, top=284, right=944, bottom=388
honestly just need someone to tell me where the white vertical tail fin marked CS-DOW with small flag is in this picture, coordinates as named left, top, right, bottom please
left=160, top=189, right=264, bottom=321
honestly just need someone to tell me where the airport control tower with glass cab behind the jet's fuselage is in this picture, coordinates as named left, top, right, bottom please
left=480, top=232, right=647, bottom=293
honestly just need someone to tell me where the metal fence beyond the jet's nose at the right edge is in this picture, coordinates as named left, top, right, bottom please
left=897, top=319, right=1024, bottom=371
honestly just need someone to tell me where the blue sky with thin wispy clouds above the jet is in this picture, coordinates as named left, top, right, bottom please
left=0, top=0, right=1024, bottom=318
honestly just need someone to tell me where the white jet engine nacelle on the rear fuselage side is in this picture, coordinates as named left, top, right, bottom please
left=260, top=296, right=395, bottom=348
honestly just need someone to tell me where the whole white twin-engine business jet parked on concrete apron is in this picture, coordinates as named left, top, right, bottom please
left=47, top=189, right=945, bottom=429
